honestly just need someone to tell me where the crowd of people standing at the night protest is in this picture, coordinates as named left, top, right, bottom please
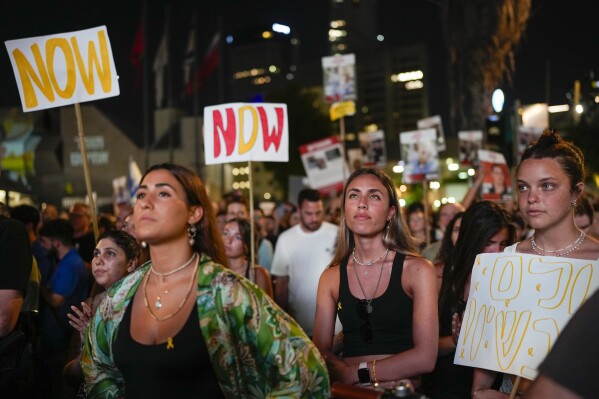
left=0, top=131, right=599, bottom=399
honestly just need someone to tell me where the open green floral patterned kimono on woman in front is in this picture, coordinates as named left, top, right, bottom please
left=81, top=254, right=330, bottom=399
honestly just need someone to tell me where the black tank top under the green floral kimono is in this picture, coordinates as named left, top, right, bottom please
left=113, top=301, right=224, bottom=399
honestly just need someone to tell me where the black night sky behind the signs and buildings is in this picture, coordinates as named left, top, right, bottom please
left=0, top=0, right=599, bottom=144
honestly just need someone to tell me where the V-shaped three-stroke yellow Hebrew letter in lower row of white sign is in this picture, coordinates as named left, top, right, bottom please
left=495, top=310, right=532, bottom=370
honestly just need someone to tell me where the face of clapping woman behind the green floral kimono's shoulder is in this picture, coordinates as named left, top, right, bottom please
left=92, top=238, right=135, bottom=289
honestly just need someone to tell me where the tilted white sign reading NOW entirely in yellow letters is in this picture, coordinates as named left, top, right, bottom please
left=5, top=26, right=119, bottom=112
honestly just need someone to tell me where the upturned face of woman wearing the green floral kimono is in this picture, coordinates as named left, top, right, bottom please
left=133, top=169, right=203, bottom=245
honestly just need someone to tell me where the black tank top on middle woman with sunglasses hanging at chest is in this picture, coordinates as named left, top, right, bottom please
left=337, top=253, right=414, bottom=357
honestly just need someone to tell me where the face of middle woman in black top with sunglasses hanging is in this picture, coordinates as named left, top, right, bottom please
left=344, top=175, right=395, bottom=236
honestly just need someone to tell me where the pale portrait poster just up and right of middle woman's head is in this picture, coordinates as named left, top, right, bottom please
left=399, top=129, right=439, bottom=184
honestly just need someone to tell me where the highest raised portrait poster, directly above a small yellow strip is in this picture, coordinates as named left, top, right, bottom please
left=322, top=54, right=358, bottom=103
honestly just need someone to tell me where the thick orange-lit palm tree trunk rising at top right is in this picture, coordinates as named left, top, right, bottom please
left=441, top=0, right=531, bottom=132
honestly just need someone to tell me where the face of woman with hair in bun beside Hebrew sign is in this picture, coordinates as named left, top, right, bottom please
left=517, top=158, right=584, bottom=229
